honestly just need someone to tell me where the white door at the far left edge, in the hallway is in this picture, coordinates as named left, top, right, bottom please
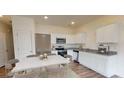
left=0, top=32, right=7, bottom=67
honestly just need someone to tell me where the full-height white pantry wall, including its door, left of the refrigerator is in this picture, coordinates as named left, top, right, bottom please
left=12, top=16, right=35, bottom=59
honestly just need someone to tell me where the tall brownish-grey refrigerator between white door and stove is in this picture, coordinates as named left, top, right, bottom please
left=35, top=33, right=51, bottom=54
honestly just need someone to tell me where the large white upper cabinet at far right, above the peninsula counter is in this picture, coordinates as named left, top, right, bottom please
left=96, top=24, right=119, bottom=43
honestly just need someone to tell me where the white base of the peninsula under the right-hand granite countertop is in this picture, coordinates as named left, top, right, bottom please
left=79, top=52, right=116, bottom=77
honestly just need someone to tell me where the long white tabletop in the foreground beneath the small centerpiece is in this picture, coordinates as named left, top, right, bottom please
left=11, top=55, right=70, bottom=73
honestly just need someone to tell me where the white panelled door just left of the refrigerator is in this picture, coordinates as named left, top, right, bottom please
left=17, top=30, right=33, bottom=58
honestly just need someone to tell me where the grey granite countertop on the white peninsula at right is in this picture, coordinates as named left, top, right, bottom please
left=74, top=49, right=117, bottom=56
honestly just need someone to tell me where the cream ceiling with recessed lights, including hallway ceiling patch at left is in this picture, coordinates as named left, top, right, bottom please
left=0, top=15, right=103, bottom=28
